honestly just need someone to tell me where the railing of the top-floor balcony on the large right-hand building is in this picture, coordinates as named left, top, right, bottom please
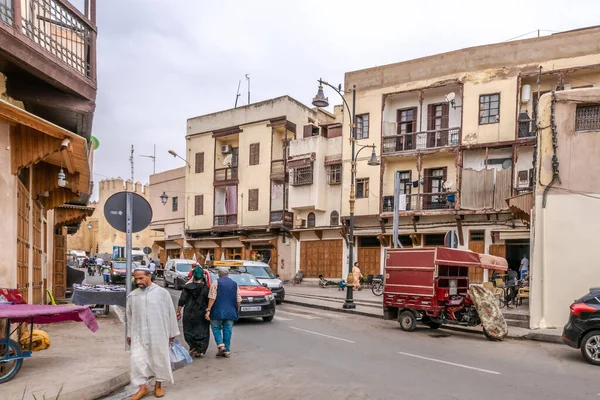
left=383, top=128, right=460, bottom=154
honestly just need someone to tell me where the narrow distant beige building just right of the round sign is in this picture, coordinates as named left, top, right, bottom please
left=149, top=167, right=188, bottom=264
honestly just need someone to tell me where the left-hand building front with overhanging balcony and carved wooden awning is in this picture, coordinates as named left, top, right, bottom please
left=0, top=0, right=97, bottom=304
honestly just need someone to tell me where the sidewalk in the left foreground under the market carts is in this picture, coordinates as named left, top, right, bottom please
left=0, top=307, right=129, bottom=400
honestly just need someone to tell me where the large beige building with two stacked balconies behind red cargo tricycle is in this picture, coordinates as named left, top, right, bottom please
left=328, top=28, right=600, bottom=288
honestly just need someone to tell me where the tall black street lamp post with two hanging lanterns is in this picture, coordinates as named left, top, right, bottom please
left=312, top=79, right=379, bottom=309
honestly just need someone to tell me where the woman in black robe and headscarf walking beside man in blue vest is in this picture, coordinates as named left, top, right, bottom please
left=177, top=267, right=210, bottom=357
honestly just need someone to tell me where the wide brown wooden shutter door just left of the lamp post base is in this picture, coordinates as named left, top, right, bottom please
left=299, top=240, right=343, bottom=278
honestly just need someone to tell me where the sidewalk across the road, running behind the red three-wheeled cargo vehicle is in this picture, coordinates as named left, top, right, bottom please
left=284, top=285, right=562, bottom=343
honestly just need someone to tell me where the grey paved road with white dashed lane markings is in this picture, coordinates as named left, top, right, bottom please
left=105, top=282, right=600, bottom=400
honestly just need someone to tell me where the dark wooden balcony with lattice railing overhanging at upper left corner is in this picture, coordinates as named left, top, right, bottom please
left=0, top=0, right=97, bottom=100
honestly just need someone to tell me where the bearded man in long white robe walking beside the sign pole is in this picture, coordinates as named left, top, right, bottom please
left=127, top=267, right=179, bottom=400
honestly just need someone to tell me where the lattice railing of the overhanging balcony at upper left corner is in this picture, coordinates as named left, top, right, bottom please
left=0, top=0, right=96, bottom=80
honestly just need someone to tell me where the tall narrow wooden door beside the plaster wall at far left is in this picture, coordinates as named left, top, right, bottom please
left=17, top=181, right=30, bottom=303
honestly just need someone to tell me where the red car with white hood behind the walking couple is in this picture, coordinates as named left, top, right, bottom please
left=208, top=269, right=275, bottom=322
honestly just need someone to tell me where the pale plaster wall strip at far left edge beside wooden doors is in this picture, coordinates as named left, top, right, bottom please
left=0, top=123, right=17, bottom=288
